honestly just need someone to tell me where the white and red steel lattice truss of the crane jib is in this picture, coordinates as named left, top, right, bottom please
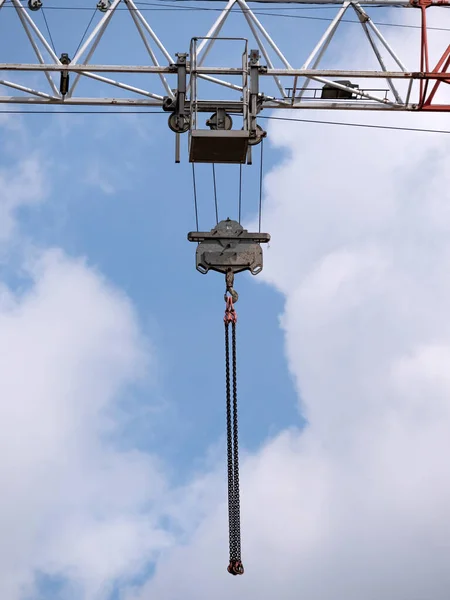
left=0, top=0, right=450, bottom=124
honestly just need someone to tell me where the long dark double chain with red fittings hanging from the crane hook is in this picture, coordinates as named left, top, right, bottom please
left=224, top=271, right=244, bottom=575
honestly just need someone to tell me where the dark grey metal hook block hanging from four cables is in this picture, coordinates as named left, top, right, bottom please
left=188, top=219, right=270, bottom=275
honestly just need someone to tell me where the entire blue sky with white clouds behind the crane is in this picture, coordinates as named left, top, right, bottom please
left=0, top=0, right=450, bottom=600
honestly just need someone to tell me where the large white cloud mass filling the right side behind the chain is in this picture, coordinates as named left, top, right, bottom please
left=130, top=5, right=450, bottom=600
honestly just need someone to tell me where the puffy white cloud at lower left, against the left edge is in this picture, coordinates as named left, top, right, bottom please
left=0, top=246, right=174, bottom=600
